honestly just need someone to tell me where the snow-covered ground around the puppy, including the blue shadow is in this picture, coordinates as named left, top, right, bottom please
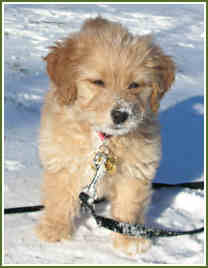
left=3, top=3, right=205, bottom=265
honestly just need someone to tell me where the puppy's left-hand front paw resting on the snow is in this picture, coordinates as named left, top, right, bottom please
left=35, top=221, right=72, bottom=242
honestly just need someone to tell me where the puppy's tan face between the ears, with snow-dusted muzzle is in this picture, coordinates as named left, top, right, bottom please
left=76, top=48, right=152, bottom=135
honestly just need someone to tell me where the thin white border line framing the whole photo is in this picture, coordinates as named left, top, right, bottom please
left=2, top=2, right=207, bottom=267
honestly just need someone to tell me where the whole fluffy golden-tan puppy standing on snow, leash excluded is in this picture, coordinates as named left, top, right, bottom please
left=37, top=17, right=175, bottom=254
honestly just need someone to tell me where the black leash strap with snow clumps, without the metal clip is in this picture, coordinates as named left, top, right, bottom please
left=4, top=182, right=204, bottom=238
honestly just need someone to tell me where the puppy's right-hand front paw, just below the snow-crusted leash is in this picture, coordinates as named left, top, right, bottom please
left=113, top=234, right=151, bottom=256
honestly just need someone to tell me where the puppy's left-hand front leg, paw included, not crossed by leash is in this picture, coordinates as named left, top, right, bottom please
left=36, top=170, right=79, bottom=242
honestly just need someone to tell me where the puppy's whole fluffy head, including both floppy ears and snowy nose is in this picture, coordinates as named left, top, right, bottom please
left=46, top=18, right=175, bottom=135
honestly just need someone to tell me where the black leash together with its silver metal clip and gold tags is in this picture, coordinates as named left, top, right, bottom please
left=4, top=133, right=204, bottom=238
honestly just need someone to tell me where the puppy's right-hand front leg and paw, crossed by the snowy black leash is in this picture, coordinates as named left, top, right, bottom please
left=112, top=179, right=151, bottom=255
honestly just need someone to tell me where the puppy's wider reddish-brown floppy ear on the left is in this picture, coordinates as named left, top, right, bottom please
left=44, top=39, right=78, bottom=105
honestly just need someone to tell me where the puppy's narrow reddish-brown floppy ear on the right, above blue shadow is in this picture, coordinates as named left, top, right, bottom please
left=150, top=48, right=175, bottom=113
